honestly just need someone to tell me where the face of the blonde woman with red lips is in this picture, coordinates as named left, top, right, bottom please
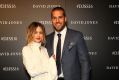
left=33, top=27, right=44, bottom=43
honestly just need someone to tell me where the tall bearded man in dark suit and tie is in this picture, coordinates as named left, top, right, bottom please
left=46, top=7, right=91, bottom=80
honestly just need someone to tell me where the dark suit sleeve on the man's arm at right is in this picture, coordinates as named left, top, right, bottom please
left=77, top=34, right=91, bottom=80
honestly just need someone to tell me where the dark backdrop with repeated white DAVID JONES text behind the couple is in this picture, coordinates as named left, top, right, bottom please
left=0, top=0, right=119, bottom=80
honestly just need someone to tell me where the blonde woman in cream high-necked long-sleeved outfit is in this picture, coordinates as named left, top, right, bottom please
left=22, top=22, right=57, bottom=80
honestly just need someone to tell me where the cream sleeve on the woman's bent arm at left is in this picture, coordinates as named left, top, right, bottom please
left=22, top=47, right=48, bottom=77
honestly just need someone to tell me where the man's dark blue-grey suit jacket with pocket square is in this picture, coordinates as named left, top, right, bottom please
left=46, top=28, right=91, bottom=80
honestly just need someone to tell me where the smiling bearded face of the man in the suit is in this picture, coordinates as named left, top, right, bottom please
left=51, top=10, right=66, bottom=32
